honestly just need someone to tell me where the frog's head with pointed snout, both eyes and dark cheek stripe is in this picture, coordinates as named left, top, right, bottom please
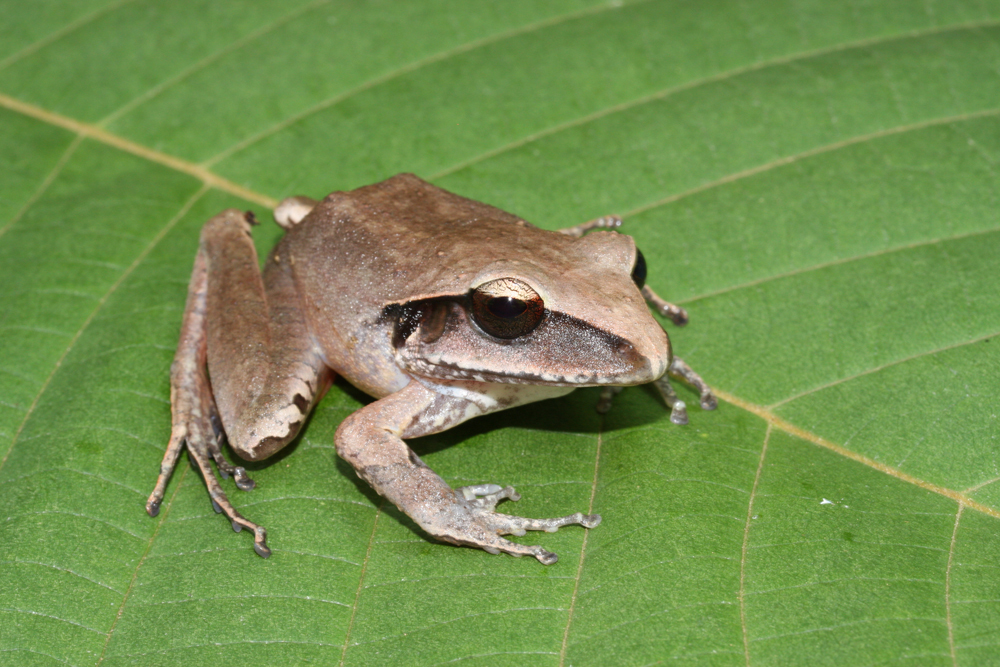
left=387, top=228, right=671, bottom=386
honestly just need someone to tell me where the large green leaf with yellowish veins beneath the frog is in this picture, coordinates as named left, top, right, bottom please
left=0, top=0, right=1000, bottom=667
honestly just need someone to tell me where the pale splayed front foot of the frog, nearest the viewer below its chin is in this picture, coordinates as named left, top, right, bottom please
left=438, top=484, right=601, bottom=565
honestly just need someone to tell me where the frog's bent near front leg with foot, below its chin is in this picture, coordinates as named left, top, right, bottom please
left=336, top=380, right=601, bottom=565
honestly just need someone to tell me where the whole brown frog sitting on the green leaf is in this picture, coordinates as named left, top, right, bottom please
left=146, top=174, right=717, bottom=565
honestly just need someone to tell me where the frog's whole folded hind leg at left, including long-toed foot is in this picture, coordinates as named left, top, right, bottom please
left=146, top=209, right=330, bottom=557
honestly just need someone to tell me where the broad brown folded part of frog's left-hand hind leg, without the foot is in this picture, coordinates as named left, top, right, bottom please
left=201, top=209, right=330, bottom=460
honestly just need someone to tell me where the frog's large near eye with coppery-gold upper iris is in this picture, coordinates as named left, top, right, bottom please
left=472, top=278, right=545, bottom=340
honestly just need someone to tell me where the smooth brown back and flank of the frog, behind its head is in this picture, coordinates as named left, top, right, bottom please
left=275, top=174, right=572, bottom=396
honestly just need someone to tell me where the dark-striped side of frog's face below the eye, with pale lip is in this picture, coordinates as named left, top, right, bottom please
left=392, top=300, right=670, bottom=387
